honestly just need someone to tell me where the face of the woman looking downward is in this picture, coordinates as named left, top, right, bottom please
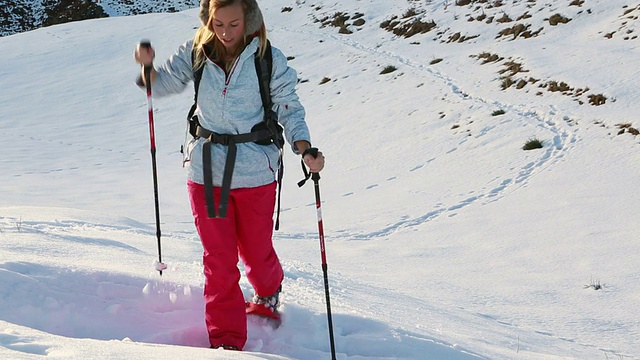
left=211, top=1, right=244, bottom=52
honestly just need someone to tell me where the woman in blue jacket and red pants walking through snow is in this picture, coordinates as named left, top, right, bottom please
left=135, top=0, right=324, bottom=350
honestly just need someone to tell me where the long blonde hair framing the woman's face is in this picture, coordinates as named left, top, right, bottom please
left=193, top=0, right=267, bottom=71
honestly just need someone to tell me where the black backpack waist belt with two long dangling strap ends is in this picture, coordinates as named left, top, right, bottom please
left=196, top=126, right=272, bottom=218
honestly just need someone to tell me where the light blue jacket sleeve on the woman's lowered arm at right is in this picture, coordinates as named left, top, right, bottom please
left=270, top=46, right=311, bottom=154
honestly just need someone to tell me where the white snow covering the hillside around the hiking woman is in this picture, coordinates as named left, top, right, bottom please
left=0, top=0, right=640, bottom=360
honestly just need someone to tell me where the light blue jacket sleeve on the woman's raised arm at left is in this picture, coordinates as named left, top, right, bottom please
left=151, top=40, right=193, bottom=97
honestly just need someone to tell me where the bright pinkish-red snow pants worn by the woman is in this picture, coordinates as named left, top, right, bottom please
left=187, top=181, right=284, bottom=349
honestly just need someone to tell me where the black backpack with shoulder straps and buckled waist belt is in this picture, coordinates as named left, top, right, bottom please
left=185, top=41, right=284, bottom=230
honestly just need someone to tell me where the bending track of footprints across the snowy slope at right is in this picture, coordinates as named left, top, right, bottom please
left=270, top=26, right=580, bottom=236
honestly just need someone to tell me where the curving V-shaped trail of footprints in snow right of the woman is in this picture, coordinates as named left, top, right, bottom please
left=270, top=26, right=580, bottom=239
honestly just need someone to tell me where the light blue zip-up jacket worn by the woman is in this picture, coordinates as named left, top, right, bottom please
left=152, top=23, right=311, bottom=189
